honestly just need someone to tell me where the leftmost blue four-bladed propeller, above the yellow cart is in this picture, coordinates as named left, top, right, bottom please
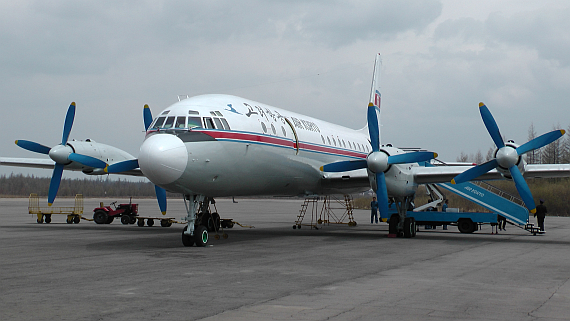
left=16, top=102, right=107, bottom=206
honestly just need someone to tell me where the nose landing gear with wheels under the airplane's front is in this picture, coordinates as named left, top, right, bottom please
left=182, top=195, right=227, bottom=247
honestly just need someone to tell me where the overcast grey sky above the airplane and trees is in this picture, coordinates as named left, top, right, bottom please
left=0, top=0, right=570, bottom=177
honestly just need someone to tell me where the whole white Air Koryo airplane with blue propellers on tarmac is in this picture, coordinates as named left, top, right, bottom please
left=0, top=54, right=570, bottom=246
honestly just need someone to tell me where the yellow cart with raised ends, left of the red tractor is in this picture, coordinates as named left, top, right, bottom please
left=28, top=193, right=83, bottom=224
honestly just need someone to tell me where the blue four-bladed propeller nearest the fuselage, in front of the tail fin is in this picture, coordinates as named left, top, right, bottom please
left=321, top=103, right=437, bottom=218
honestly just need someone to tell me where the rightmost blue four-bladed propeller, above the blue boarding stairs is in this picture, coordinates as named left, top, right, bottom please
left=451, top=103, right=565, bottom=213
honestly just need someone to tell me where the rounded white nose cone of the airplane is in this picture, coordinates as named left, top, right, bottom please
left=139, top=134, right=188, bottom=185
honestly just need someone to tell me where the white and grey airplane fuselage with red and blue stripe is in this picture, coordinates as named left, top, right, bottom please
left=135, top=95, right=418, bottom=197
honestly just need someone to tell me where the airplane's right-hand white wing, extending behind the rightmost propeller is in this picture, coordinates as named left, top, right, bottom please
left=414, top=164, right=570, bottom=184
